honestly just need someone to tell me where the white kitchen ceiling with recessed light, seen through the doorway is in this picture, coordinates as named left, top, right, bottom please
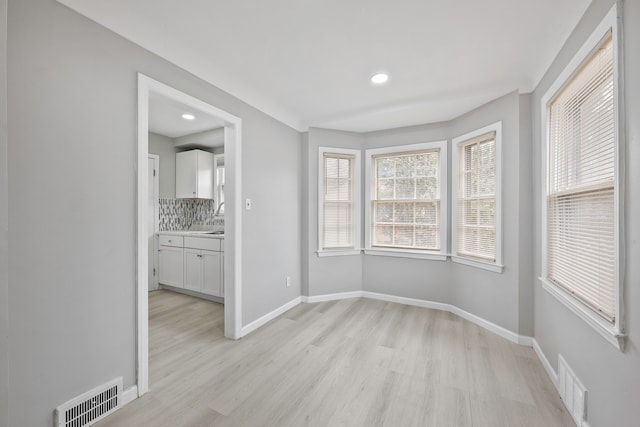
left=149, top=92, right=224, bottom=138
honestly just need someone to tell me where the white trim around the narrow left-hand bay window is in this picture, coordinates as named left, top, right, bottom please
left=317, top=147, right=362, bottom=257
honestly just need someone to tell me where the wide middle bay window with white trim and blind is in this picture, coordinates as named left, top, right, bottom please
left=365, top=141, right=447, bottom=260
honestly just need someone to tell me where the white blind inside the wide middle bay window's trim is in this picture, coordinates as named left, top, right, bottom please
left=371, top=149, right=441, bottom=251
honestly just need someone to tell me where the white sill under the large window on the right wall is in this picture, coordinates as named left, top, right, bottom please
left=538, top=277, right=627, bottom=352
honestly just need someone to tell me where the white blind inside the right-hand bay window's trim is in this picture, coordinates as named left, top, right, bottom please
left=456, top=132, right=496, bottom=262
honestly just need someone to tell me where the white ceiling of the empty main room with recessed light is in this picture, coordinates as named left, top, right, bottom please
left=58, top=0, right=590, bottom=131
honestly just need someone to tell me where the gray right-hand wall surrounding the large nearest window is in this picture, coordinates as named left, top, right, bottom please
left=533, top=0, right=640, bottom=427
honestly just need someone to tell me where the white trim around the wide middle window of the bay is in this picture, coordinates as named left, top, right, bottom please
left=364, top=140, right=449, bottom=261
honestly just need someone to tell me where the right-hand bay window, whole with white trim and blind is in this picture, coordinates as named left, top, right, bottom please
left=452, top=122, right=502, bottom=272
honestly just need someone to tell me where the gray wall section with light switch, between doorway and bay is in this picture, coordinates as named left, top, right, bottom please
left=240, top=107, right=302, bottom=325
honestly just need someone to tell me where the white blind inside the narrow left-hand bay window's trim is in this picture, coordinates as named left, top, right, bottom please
left=321, top=153, right=355, bottom=249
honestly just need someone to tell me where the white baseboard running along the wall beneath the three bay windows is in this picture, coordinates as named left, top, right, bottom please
left=302, top=291, right=533, bottom=347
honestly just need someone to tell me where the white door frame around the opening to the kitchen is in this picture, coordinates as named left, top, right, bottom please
left=136, top=73, right=242, bottom=396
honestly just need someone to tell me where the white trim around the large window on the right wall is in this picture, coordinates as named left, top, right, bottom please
left=538, top=3, right=626, bottom=351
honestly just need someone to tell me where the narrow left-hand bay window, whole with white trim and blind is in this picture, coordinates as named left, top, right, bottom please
left=318, top=147, right=361, bottom=256
